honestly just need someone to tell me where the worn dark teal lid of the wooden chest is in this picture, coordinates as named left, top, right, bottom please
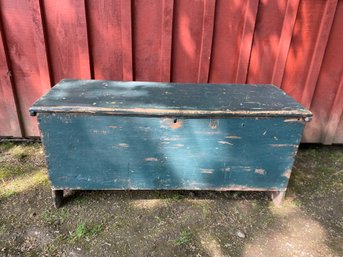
left=30, top=79, right=312, bottom=117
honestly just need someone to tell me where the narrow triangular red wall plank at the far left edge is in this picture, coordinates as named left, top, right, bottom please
left=0, top=15, right=22, bottom=137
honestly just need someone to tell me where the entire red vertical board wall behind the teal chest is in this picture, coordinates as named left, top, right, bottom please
left=0, top=0, right=343, bottom=144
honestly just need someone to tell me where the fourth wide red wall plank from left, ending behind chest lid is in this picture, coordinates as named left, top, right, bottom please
left=86, top=0, right=132, bottom=80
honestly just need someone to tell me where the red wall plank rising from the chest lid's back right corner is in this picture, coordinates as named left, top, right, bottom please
left=248, top=0, right=296, bottom=86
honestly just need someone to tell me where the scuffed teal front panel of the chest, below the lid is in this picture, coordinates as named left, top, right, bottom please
left=38, top=114, right=303, bottom=190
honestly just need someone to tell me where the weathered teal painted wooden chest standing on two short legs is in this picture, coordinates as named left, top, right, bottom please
left=30, top=80, right=312, bottom=206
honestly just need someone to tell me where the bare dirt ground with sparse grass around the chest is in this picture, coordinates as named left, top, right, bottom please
left=0, top=142, right=343, bottom=257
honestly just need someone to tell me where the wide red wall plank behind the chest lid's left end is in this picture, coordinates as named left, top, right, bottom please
left=0, top=0, right=51, bottom=136
